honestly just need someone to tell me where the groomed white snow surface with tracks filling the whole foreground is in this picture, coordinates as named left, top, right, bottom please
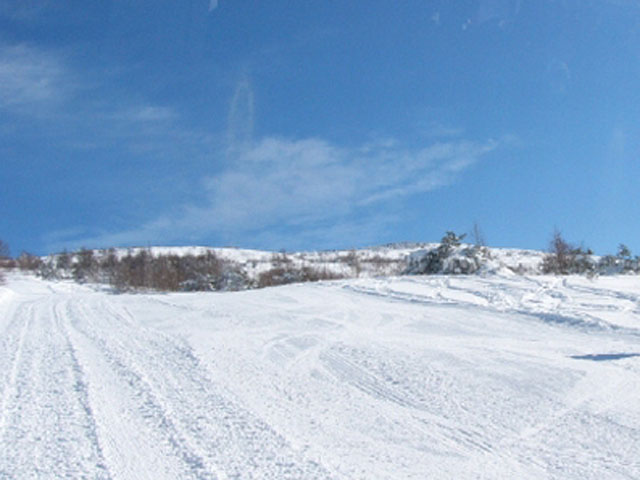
left=0, top=274, right=640, bottom=480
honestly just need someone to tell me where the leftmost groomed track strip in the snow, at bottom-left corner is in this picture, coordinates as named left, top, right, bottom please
left=0, top=297, right=111, bottom=480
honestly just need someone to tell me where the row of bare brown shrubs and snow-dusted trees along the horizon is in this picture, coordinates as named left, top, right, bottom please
left=0, top=231, right=640, bottom=291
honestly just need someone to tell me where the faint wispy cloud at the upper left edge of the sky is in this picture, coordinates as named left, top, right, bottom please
left=0, top=43, right=215, bottom=161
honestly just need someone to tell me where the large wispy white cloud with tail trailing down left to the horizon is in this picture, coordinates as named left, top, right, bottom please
left=53, top=133, right=500, bottom=247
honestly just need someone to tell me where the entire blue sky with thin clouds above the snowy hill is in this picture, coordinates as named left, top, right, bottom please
left=0, top=0, right=640, bottom=254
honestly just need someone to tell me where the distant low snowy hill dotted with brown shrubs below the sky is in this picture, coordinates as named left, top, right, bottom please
left=38, top=243, right=544, bottom=291
